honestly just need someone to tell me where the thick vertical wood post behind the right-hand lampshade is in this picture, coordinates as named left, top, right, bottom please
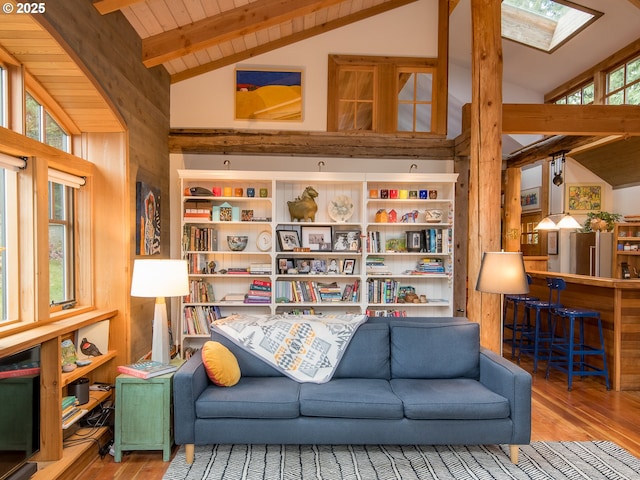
left=467, top=0, right=502, bottom=352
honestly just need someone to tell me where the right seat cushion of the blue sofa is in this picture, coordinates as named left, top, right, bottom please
left=390, top=378, right=510, bottom=420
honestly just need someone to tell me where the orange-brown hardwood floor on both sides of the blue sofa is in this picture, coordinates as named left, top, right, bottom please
left=77, top=350, right=640, bottom=480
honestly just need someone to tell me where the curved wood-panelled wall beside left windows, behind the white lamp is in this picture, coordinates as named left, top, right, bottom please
left=42, top=0, right=170, bottom=363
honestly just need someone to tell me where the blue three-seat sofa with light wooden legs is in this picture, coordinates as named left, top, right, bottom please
left=173, top=317, right=531, bottom=463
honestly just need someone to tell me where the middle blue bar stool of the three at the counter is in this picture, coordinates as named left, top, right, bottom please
left=518, top=278, right=567, bottom=373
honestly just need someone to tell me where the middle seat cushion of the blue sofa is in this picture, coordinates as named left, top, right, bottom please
left=300, top=378, right=403, bottom=419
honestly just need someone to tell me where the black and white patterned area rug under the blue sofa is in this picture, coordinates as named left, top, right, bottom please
left=163, top=441, right=640, bottom=480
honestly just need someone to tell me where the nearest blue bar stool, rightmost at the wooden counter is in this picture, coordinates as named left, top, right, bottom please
left=546, top=307, right=611, bottom=390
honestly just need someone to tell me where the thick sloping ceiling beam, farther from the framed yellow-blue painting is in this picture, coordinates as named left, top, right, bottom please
left=142, top=0, right=350, bottom=67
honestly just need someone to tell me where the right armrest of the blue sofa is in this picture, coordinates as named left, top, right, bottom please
left=480, top=347, right=531, bottom=445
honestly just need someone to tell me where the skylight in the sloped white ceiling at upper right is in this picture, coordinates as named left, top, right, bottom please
left=502, top=0, right=602, bottom=53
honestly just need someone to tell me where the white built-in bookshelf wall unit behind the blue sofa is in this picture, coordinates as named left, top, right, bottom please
left=178, top=170, right=457, bottom=355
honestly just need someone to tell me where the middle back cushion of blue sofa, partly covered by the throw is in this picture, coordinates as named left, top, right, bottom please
left=333, top=322, right=391, bottom=380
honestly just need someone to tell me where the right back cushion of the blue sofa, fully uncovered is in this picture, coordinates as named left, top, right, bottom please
left=390, top=322, right=480, bottom=378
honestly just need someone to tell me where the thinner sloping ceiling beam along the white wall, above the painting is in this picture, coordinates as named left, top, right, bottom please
left=171, top=0, right=417, bottom=83
